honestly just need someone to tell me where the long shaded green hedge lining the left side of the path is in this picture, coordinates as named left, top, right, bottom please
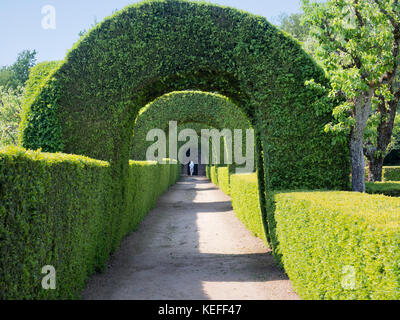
left=0, top=148, right=178, bottom=299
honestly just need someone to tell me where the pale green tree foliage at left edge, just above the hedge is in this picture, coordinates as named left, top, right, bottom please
left=0, top=87, right=24, bottom=147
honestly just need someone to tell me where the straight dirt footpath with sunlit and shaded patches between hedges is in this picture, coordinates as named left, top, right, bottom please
left=82, top=178, right=298, bottom=300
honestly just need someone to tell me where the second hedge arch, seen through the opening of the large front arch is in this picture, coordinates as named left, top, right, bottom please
left=131, top=91, right=251, bottom=160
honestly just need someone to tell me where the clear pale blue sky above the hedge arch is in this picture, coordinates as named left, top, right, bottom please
left=0, top=0, right=300, bottom=66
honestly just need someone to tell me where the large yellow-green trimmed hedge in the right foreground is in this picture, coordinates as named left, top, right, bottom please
left=274, top=192, right=400, bottom=300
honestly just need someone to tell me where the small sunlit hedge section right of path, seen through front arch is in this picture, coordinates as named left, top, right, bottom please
left=230, top=174, right=267, bottom=242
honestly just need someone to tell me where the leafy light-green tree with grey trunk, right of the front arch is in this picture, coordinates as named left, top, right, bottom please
left=302, top=0, right=400, bottom=192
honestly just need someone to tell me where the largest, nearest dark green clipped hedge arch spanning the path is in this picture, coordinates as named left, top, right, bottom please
left=21, top=0, right=349, bottom=196
